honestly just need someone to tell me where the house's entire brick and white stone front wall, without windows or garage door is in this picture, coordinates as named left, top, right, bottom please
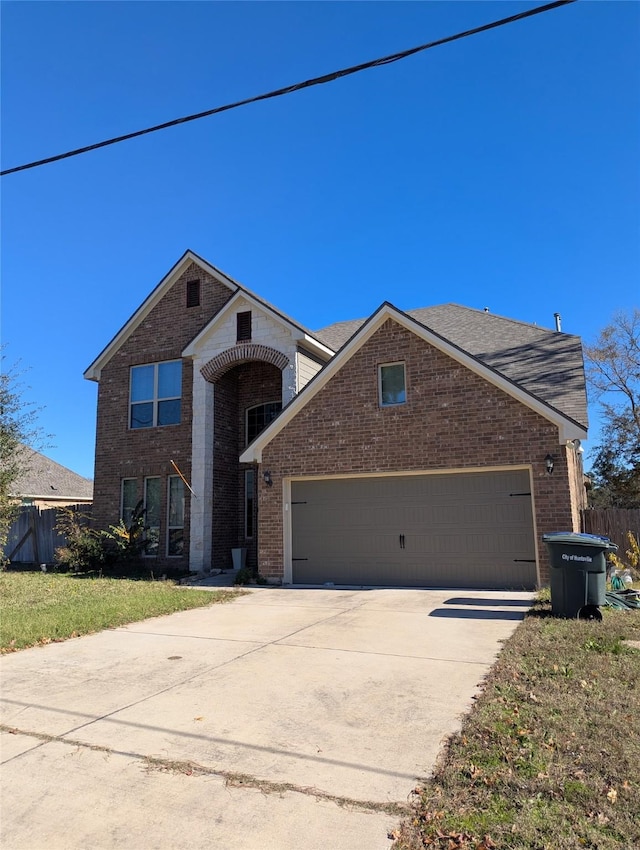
left=89, top=252, right=586, bottom=581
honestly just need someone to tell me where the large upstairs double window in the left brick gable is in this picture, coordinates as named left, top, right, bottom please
left=129, top=360, right=182, bottom=428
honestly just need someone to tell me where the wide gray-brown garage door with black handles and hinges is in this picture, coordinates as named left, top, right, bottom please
left=291, top=470, right=536, bottom=588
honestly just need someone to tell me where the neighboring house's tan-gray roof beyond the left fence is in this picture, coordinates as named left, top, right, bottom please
left=11, top=446, right=93, bottom=502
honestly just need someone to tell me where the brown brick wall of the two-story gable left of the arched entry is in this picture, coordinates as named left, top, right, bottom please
left=93, top=264, right=233, bottom=566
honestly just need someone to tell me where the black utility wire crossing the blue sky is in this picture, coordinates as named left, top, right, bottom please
left=0, top=0, right=576, bottom=177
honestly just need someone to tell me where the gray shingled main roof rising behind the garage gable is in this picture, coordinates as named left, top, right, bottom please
left=315, top=304, right=588, bottom=427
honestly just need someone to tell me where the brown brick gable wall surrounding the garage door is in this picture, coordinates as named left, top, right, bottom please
left=258, top=320, right=579, bottom=582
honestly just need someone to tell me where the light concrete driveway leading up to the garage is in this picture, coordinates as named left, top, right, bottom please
left=0, top=588, right=532, bottom=850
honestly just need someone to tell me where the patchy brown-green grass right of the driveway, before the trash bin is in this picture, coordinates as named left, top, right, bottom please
left=393, top=596, right=640, bottom=850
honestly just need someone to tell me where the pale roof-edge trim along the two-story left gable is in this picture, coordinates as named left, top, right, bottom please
left=84, top=249, right=335, bottom=381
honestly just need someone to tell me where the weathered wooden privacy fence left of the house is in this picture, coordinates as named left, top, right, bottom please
left=4, top=505, right=91, bottom=564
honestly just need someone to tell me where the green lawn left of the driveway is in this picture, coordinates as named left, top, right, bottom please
left=0, top=572, right=238, bottom=653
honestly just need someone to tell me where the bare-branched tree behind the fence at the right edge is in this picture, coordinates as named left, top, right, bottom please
left=585, top=309, right=640, bottom=508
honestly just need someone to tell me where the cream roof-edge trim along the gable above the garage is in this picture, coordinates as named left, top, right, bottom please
left=240, top=302, right=587, bottom=463
